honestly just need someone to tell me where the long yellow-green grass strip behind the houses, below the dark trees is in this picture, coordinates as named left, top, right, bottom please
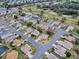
left=23, top=7, right=79, bottom=24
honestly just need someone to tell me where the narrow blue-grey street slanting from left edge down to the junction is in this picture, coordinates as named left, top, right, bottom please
left=1, top=21, right=41, bottom=48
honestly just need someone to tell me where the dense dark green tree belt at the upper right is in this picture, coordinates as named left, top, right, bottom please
left=42, top=1, right=79, bottom=15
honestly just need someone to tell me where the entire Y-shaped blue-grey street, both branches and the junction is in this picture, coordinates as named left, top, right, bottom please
left=0, top=19, right=67, bottom=59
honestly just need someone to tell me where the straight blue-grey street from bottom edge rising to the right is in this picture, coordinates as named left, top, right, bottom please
left=32, top=30, right=67, bottom=59
